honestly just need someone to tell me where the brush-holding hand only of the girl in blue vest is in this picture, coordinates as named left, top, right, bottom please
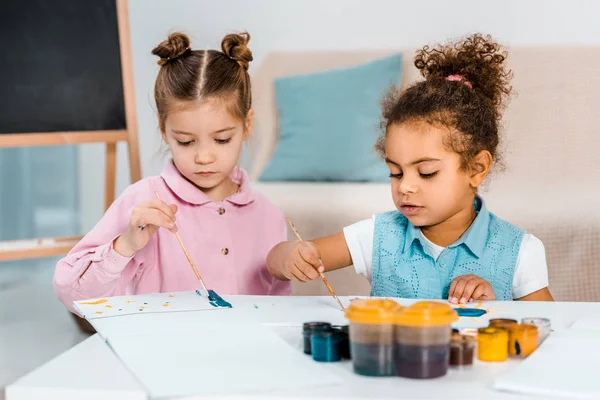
left=267, top=241, right=325, bottom=282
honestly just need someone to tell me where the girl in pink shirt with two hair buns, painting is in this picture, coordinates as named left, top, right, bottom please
left=54, top=33, right=290, bottom=310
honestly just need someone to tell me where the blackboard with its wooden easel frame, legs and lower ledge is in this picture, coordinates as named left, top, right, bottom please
left=0, top=0, right=141, bottom=261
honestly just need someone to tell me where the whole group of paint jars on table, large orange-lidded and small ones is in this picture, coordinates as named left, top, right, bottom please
left=303, top=299, right=551, bottom=379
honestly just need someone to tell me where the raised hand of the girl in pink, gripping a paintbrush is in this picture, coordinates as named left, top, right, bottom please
left=113, top=200, right=177, bottom=257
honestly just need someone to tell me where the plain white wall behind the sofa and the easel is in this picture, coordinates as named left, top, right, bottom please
left=80, top=0, right=600, bottom=232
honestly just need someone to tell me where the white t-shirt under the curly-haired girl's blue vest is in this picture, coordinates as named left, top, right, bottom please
left=344, top=216, right=548, bottom=299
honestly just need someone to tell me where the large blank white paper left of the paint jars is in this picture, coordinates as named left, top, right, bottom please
left=108, top=319, right=343, bottom=398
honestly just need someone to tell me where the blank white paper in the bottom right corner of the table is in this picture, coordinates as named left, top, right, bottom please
left=492, top=329, right=600, bottom=399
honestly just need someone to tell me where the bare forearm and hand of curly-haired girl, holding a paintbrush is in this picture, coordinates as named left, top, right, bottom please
left=267, top=232, right=352, bottom=282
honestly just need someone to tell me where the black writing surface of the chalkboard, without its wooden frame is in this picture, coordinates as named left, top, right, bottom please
left=0, top=0, right=127, bottom=134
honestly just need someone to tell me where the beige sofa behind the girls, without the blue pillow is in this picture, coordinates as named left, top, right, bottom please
left=249, top=47, right=600, bottom=301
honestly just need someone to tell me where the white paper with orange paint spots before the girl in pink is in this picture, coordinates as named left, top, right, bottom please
left=73, top=291, right=225, bottom=320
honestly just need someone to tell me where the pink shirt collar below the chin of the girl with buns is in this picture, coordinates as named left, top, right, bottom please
left=160, top=160, right=255, bottom=206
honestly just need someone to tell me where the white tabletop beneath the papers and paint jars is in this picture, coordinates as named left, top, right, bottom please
left=6, top=296, right=600, bottom=400
